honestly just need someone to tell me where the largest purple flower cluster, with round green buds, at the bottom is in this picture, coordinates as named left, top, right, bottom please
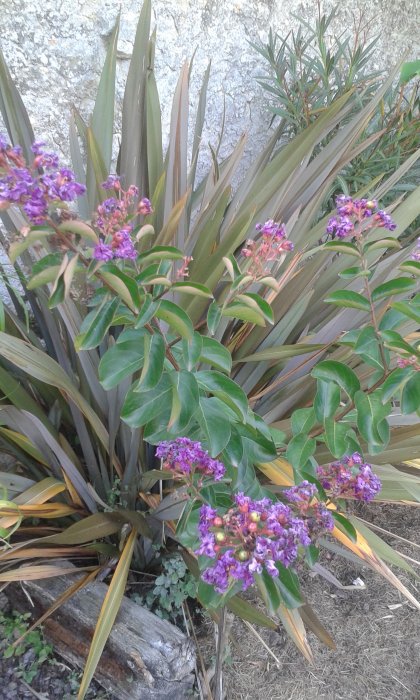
left=196, top=490, right=334, bottom=594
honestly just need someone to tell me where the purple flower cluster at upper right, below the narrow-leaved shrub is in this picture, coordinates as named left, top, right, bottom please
left=326, top=194, right=396, bottom=238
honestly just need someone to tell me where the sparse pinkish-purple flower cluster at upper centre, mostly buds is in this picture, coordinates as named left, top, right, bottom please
left=242, top=219, right=293, bottom=279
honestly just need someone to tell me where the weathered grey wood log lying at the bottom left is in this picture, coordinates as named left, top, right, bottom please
left=9, top=574, right=195, bottom=700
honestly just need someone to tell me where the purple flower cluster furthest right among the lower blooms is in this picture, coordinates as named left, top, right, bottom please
left=317, top=452, right=381, bottom=503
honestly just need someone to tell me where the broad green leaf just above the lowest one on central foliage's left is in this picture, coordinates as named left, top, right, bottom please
left=99, top=330, right=145, bottom=391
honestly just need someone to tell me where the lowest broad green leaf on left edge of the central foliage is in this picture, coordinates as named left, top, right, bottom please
left=121, top=373, right=172, bottom=428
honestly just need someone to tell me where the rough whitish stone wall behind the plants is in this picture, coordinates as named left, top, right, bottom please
left=0, top=0, right=420, bottom=178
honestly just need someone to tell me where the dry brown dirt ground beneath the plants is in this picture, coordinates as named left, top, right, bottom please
left=0, top=505, right=420, bottom=700
